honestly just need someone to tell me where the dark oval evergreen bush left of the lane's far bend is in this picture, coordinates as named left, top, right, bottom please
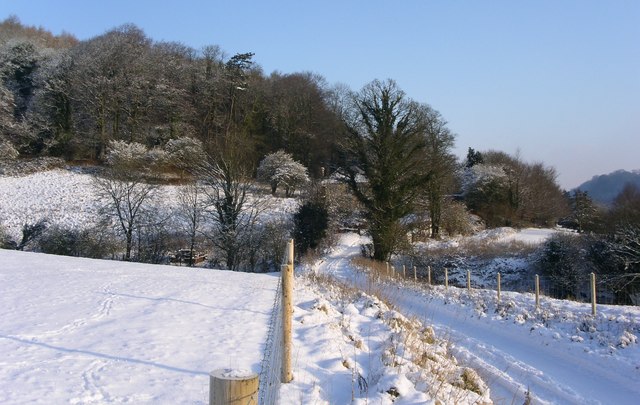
left=293, top=201, right=329, bottom=255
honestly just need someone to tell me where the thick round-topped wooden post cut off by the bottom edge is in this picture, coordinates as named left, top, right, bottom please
left=209, top=369, right=258, bottom=405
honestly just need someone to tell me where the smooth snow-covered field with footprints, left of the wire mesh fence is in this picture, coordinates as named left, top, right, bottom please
left=0, top=250, right=277, bottom=404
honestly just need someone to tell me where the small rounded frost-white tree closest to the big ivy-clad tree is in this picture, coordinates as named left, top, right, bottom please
left=258, top=150, right=309, bottom=197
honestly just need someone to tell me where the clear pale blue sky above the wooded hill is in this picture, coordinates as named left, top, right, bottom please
left=0, top=0, right=640, bottom=188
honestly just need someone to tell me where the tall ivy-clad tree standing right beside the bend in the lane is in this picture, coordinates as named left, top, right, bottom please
left=340, top=80, right=431, bottom=260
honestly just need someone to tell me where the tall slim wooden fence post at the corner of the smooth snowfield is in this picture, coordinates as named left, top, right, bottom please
left=282, top=239, right=293, bottom=383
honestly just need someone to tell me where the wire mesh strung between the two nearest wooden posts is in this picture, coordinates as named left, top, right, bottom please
left=258, top=277, right=283, bottom=405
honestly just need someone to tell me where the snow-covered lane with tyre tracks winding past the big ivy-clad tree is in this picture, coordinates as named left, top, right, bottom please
left=317, top=235, right=640, bottom=404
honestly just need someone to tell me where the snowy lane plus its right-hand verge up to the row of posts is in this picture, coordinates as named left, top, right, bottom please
left=314, top=234, right=640, bottom=404
